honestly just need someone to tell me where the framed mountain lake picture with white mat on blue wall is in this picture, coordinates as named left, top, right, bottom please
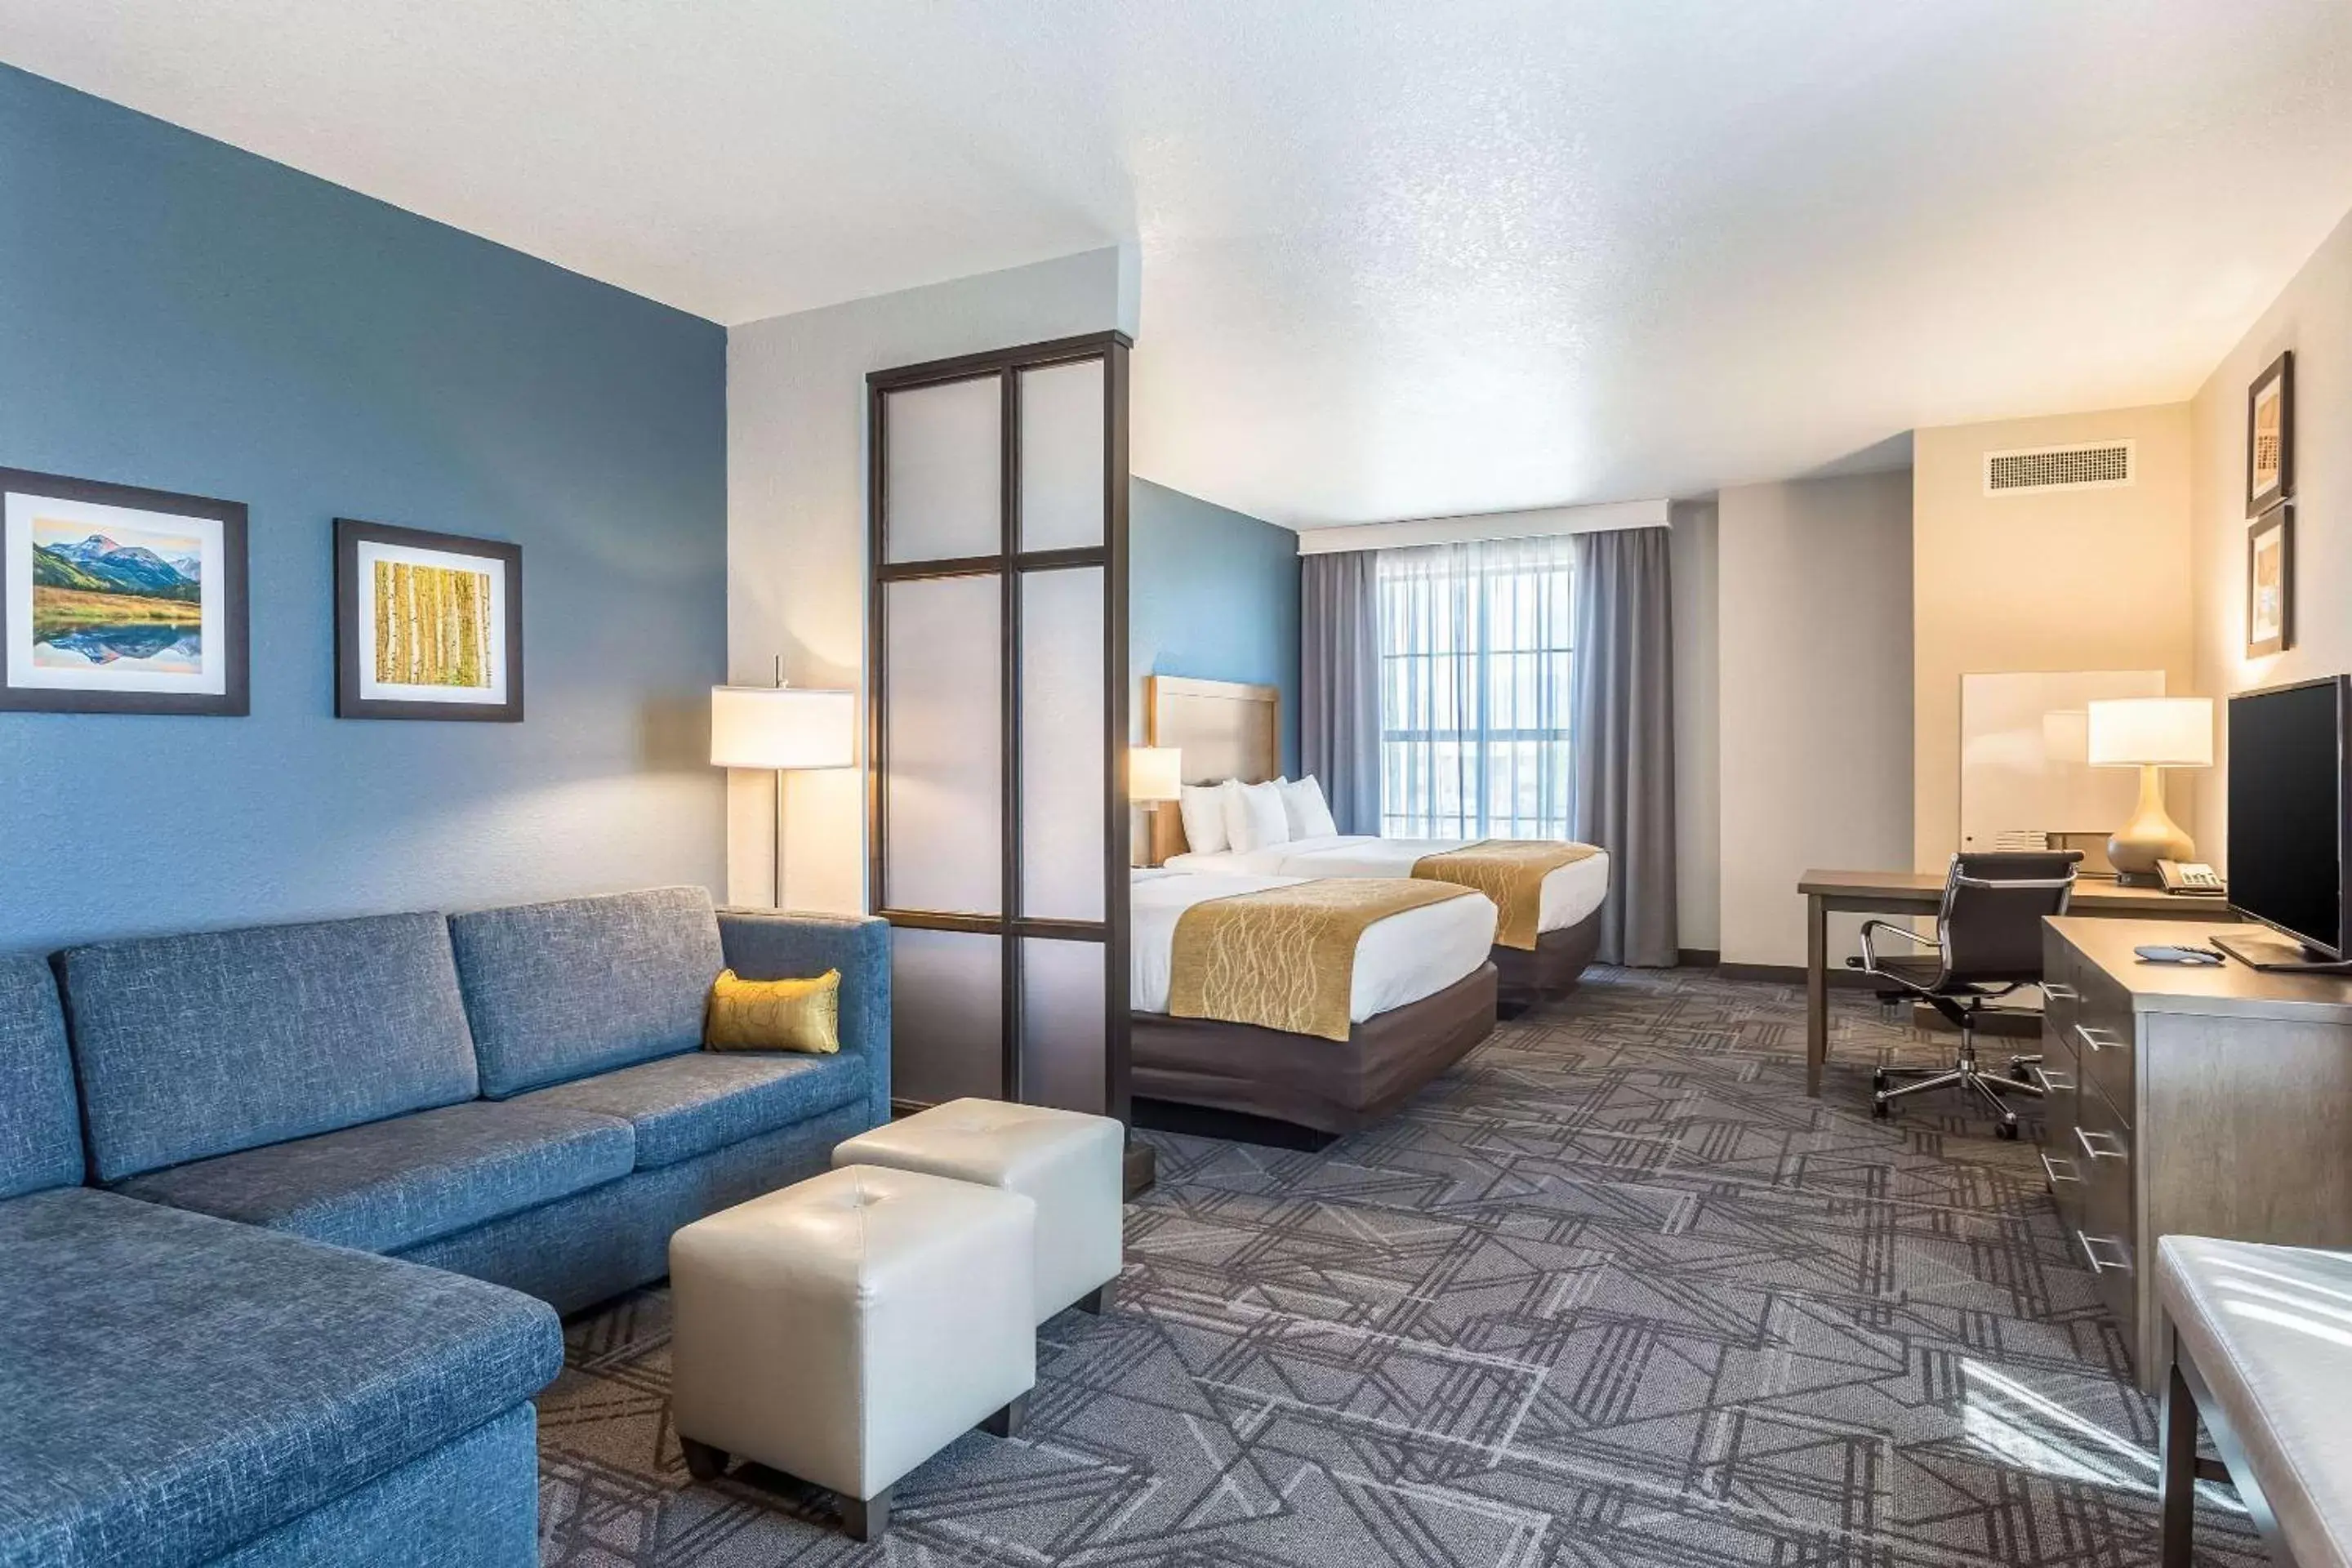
left=0, top=468, right=249, bottom=717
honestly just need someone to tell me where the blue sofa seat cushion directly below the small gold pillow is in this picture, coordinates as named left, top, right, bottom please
left=515, top=1051, right=866, bottom=1171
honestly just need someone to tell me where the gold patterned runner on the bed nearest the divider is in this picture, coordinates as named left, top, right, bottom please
left=1169, top=877, right=1470, bottom=1039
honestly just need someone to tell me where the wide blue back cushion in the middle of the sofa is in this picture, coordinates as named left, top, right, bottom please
left=59, top=915, right=475, bottom=1183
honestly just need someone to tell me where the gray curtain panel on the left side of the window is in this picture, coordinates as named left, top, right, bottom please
left=1298, top=550, right=1381, bottom=832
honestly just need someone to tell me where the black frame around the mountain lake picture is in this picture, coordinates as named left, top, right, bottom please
left=0, top=468, right=252, bottom=719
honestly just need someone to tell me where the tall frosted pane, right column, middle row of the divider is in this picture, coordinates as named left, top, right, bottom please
left=1025, top=567, right=1103, bottom=920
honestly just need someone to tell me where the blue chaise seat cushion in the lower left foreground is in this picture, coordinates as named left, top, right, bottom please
left=0, top=1187, right=562, bottom=1568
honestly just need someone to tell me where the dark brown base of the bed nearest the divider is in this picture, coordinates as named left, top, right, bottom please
left=1131, top=964, right=1499, bottom=1133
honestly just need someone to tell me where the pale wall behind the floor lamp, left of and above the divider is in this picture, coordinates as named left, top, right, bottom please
left=727, top=249, right=1136, bottom=912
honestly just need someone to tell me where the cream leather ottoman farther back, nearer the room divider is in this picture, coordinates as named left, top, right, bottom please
left=833, top=1100, right=1127, bottom=1324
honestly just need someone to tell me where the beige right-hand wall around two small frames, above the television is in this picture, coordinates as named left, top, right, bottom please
left=2192, top=207, right=2352, bottom=865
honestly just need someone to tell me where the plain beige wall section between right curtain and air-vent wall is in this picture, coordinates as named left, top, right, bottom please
left=1717, top=470, right=1912, bottom=964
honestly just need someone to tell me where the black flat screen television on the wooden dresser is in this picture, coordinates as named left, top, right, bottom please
left=2218, top=675, right=2352, bottom=969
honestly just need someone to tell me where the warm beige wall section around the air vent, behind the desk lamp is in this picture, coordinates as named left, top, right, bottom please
left=1910, top=404, right=2199, bottom=870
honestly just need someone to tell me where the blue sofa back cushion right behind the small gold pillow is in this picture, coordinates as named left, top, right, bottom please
left=449, top=889, right=724, bottom=1100
